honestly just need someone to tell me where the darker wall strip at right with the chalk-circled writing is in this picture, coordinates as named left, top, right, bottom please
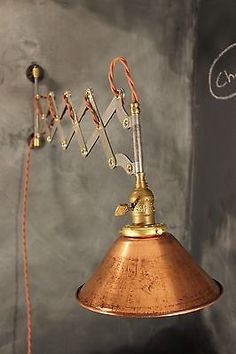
left=192, top=0, right=236, bottom=354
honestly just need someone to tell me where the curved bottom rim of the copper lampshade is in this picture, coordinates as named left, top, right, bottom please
left=76, top=279, right=223, bottom=318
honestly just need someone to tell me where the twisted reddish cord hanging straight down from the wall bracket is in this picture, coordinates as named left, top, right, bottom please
left=21, top=139, right=33, bottom=354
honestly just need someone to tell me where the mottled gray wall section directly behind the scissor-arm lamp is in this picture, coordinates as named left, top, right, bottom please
left=0, top=0, right=196, bottom=354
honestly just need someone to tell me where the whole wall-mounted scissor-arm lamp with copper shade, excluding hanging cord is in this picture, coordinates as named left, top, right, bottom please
left=28, top=57, right=222, bottom=317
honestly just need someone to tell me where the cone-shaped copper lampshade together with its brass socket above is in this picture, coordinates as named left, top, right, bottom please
left=77, top=174, right=222, bottom=317
